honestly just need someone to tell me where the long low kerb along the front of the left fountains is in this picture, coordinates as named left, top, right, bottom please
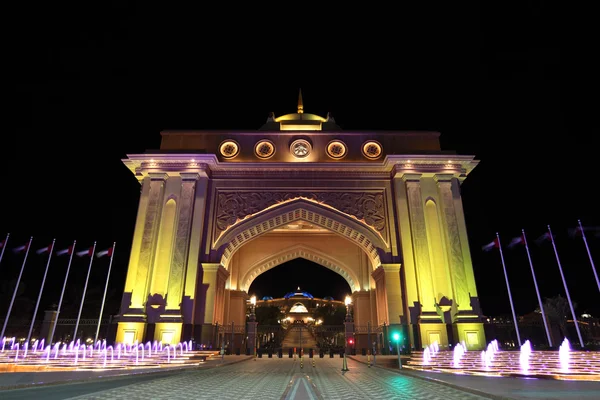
left=0, top=357, right=252, bottom=397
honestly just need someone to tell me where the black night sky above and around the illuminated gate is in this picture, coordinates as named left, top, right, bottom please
left=0, top=1, right=600, bottom=317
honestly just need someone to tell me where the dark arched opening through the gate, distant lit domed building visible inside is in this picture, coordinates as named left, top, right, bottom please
left=248, top=258, right=352, bottom=353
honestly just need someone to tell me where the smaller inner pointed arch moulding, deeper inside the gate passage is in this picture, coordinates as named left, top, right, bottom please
left=239, top=245, right=360, bottom=293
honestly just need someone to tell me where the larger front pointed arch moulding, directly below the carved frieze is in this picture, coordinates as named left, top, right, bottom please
left=213, top=198, right=388, bottom=269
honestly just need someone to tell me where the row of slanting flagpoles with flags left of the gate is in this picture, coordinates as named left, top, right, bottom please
left=0, top=233, right=116, bottom=343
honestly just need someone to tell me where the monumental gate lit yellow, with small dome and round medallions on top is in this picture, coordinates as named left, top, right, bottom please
left=117, top=100, right=485, bottom=349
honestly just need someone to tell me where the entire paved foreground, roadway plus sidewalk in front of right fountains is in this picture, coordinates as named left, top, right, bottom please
left=0, top=356, right=600, bottom=400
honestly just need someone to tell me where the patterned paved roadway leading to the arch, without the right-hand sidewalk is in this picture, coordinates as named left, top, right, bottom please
left=0, top=356, right=492, bottom=400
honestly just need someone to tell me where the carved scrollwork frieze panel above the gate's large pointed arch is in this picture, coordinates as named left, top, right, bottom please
left=216, top=192, right=387, bottom=237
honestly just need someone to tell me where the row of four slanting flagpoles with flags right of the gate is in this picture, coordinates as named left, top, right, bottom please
left=483, top=220, right=600, bottom=348
